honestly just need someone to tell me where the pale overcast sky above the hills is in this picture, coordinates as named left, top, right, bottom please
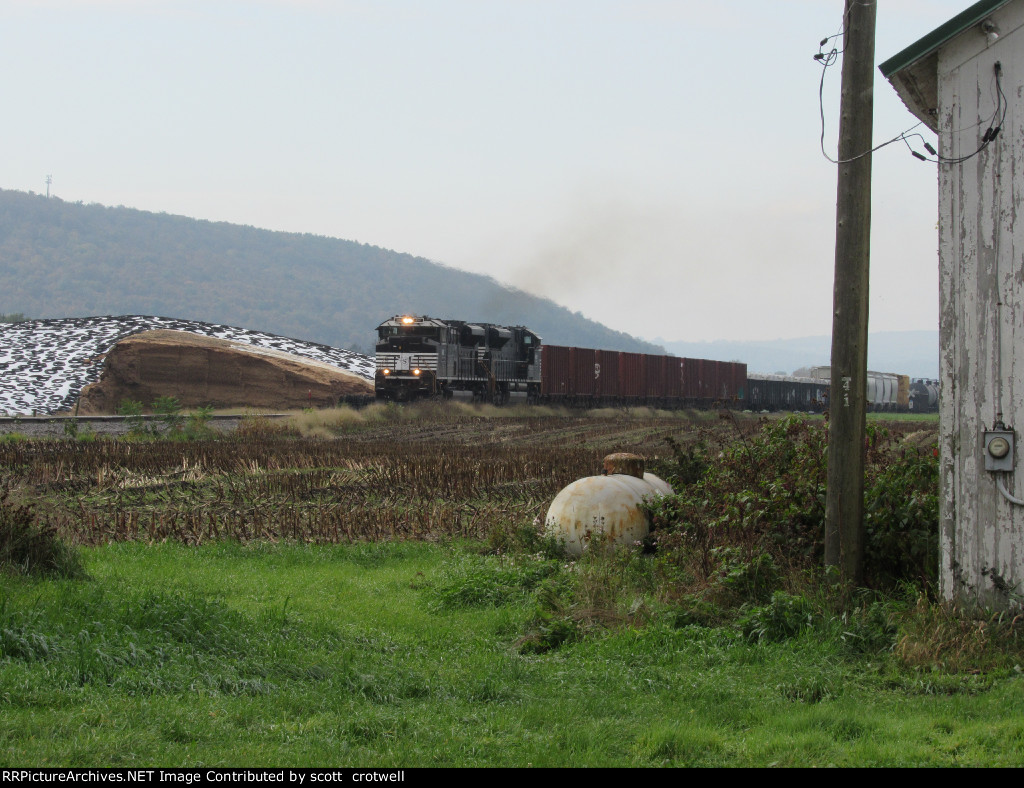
left=0, top=0, right=971, bottom=341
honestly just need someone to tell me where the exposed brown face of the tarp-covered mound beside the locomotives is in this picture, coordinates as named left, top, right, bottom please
left=79, top=330, right=373, bottom=415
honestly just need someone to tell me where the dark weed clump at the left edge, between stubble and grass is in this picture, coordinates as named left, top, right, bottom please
left=0, top=490, right=86, bottom=579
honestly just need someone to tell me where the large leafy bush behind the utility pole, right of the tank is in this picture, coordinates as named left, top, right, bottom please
left=648, top=417, right=938, bottom=601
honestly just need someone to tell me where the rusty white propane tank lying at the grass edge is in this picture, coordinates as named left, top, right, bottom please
left=545, top=453, right=672, bottom=556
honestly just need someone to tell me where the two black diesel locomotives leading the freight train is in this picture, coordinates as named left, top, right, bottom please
left=374, top=315, right=541, bottom=404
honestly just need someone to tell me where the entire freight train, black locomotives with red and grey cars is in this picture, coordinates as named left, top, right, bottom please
left=374, top=315, right=937, bottom=411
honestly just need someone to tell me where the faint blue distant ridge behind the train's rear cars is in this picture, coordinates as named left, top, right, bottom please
left=654, top=331, right=939, bottom=379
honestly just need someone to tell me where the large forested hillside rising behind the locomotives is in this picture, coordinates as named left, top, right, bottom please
left=0, top=190, right=659, bottom=352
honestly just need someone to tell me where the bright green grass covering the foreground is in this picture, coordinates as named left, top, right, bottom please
left=0, top=542, right=1024, bottom=767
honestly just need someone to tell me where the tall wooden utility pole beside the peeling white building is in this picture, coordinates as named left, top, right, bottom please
left=825, top=0, right=876, bottom=585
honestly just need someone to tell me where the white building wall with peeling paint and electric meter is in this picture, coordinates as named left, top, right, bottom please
left=938, top=2, right=1024, bottom=607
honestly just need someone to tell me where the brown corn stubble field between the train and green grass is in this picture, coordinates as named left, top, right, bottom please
left=0, top=408, right=679, bottom=544
